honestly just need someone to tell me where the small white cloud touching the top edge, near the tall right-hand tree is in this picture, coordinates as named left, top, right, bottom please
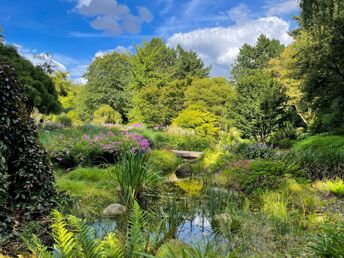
left=265, top=0, right=299, bottom=16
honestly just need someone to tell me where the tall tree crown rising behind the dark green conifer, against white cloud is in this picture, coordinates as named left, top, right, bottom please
left=231, top=34, right=284, bottom=80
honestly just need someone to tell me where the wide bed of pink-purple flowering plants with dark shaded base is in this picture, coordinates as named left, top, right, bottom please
left=40, top=126, right=150, bottom=168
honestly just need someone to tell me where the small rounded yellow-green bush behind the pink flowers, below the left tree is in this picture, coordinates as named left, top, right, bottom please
left=93, top=105, right=123, bottom=124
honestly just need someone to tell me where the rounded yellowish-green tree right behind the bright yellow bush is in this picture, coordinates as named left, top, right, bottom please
left=184, top=78, right=235, bottom=126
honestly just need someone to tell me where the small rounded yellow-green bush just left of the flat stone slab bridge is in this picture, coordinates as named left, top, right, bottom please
left=148, top=150, right=179, bottom=174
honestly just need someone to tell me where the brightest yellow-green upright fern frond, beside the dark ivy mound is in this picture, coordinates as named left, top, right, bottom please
left=51, top=211, right=77, bottom=258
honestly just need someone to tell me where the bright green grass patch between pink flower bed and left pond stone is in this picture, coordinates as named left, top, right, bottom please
left=56, top=168, right=116, bottom=217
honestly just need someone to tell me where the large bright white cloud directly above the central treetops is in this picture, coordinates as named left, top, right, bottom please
left=167, top=5, right=292, bottom=77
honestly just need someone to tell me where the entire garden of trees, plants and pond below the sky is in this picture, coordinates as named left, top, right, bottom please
left=0, top=0, right=344, bottom=258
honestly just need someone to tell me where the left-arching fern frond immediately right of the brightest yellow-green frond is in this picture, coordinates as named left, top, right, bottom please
left=67, top=216, right=101, bottom=258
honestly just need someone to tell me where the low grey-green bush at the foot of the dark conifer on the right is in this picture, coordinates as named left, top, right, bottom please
left=231, top=143, right=274, bottom=159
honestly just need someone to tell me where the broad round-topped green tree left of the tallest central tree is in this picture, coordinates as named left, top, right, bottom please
left=85, top=52, right=131, bottom=120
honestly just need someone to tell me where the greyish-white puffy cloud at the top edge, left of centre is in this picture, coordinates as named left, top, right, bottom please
left=75, top=0, right=153, bottom=35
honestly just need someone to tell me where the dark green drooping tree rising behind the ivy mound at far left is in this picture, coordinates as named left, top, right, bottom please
left=0, top=44, right=61, bottom=114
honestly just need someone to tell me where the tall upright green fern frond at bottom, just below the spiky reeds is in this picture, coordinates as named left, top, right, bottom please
left=125, top=201, right=147, bottom=257
